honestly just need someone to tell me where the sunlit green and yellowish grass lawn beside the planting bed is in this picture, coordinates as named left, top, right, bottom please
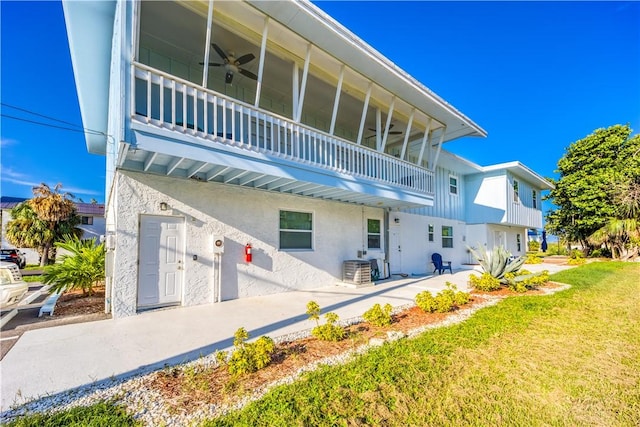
left=9, top=262, right=640, bottom=426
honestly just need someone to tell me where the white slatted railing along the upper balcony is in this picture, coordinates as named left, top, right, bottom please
left=132, top=63, right=433, bottom=194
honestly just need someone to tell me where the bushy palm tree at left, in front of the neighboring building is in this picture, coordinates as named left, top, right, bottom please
left=6, top=184, right=82, bottom=266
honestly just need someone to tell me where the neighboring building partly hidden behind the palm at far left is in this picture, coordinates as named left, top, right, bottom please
left=0, top=196, right=106, bottom=264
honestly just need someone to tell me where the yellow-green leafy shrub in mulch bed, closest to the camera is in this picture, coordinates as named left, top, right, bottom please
left=226, top=328, right=275, bottom=375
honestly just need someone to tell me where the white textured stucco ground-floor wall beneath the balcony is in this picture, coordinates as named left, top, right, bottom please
left=111, top=171, right=384, bottom=317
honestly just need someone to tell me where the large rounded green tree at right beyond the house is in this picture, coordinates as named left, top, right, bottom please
left=546, top=125, right=640, bottom=256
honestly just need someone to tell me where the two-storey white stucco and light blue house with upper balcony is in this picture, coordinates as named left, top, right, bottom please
left=63, top=0, right=549, bottom=317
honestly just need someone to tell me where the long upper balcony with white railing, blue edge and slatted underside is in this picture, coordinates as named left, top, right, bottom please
left=124, top=63, right=434, bottom=207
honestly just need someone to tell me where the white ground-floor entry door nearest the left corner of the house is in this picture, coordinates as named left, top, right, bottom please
left=138, top=215, right=184, bottom=307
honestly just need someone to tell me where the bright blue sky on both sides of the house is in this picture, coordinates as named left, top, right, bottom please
left=0, top=1, right=640, bottom=207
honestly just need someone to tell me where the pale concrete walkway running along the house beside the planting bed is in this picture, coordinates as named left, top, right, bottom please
left=0, top=264, right=566, bottom=411
